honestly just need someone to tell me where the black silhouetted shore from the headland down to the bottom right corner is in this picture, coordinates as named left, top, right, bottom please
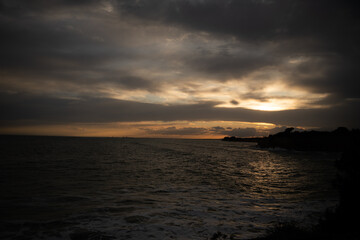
left=219, top=128, right=360, bottom=240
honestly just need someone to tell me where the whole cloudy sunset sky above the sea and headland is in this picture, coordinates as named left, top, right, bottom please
left=0, top=0, right=360, bottom=138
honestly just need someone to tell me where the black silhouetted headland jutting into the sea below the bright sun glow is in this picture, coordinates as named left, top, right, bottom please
left=223, top=127, right=360, bottom=152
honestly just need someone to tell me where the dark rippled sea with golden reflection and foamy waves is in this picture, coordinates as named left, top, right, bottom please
left=0, top=136, right=340, bottom=239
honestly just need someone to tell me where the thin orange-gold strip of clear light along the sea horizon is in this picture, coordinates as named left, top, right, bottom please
left=0, top=121, right=282, bottom=139
